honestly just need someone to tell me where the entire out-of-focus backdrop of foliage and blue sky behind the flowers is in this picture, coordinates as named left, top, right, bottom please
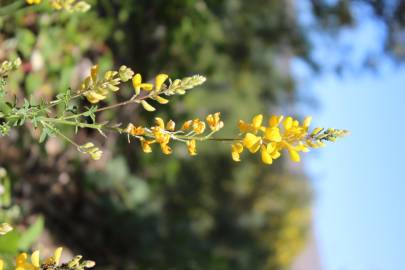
left=0, top=0, right=405, bottom=270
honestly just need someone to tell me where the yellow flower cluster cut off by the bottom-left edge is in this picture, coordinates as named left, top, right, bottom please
left=0, top=247, right=96, bottom=270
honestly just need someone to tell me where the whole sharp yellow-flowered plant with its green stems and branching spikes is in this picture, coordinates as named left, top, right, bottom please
left=0, top=60, right=347, bottom=164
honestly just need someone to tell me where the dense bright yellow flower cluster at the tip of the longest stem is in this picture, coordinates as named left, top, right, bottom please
left=232, top=114, right=348, bottom=164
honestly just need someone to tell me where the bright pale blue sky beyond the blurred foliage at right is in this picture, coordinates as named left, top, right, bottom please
left=295, top=1, right=405, bottom=270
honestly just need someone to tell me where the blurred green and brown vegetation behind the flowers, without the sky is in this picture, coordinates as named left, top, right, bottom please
left=0, top=0, right=405, bottom=269
